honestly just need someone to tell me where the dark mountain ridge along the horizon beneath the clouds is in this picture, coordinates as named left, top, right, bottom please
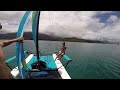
left=0, top=32, right=116, bottom=44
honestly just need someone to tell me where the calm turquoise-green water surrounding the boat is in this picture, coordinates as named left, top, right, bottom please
left=4, top=40, right=120, bottom=79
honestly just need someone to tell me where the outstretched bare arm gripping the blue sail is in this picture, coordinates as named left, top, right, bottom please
left=1, top=37, right=24, bottom=47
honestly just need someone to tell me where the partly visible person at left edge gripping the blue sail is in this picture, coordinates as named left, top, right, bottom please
left=0, top=37, right=24, bottom=79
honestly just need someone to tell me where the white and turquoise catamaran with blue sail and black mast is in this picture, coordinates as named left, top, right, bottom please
left=6, top=11, right=72, bottom=79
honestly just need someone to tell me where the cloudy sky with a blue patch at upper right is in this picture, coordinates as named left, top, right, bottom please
left=0, top=11, right=120, bottom=40
